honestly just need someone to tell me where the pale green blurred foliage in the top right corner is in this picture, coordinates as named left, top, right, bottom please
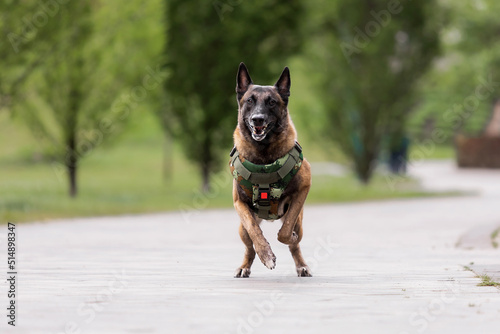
left=409, top=0, right=500, bottom=143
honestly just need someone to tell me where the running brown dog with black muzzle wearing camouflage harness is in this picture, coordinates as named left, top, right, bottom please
left=230, top=63, right=312, bottom=278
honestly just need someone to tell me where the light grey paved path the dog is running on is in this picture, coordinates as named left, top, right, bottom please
left=0, top=160, right=500, bottom=334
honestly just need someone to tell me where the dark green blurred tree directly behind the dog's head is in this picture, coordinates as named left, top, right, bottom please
left=163, top=0, right=302, bottom=191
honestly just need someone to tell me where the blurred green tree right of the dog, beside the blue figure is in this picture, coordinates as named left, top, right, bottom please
left=307, top=0, right=440, bottom=183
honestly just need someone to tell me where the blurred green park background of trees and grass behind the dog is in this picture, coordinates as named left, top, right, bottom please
left=0, top=0, right=500, bottom=222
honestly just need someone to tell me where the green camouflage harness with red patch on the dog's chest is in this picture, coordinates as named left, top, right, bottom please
left=229, top=142, right=304, bottom=220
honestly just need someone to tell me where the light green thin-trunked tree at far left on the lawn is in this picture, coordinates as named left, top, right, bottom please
left=9, top=1, right=160, bottom=197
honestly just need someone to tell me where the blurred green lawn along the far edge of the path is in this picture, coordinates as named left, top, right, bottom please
left=0, top=113, right=458, bottom=223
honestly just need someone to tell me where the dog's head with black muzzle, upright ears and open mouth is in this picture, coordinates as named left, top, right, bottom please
left=236, top=63, right=291, bottom=143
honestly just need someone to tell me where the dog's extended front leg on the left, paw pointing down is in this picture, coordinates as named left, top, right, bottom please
left=234, top=199, right=276, bottom=269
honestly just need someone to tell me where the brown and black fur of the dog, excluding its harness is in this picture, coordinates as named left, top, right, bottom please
left=233, top=63, right=312, bottom=277
